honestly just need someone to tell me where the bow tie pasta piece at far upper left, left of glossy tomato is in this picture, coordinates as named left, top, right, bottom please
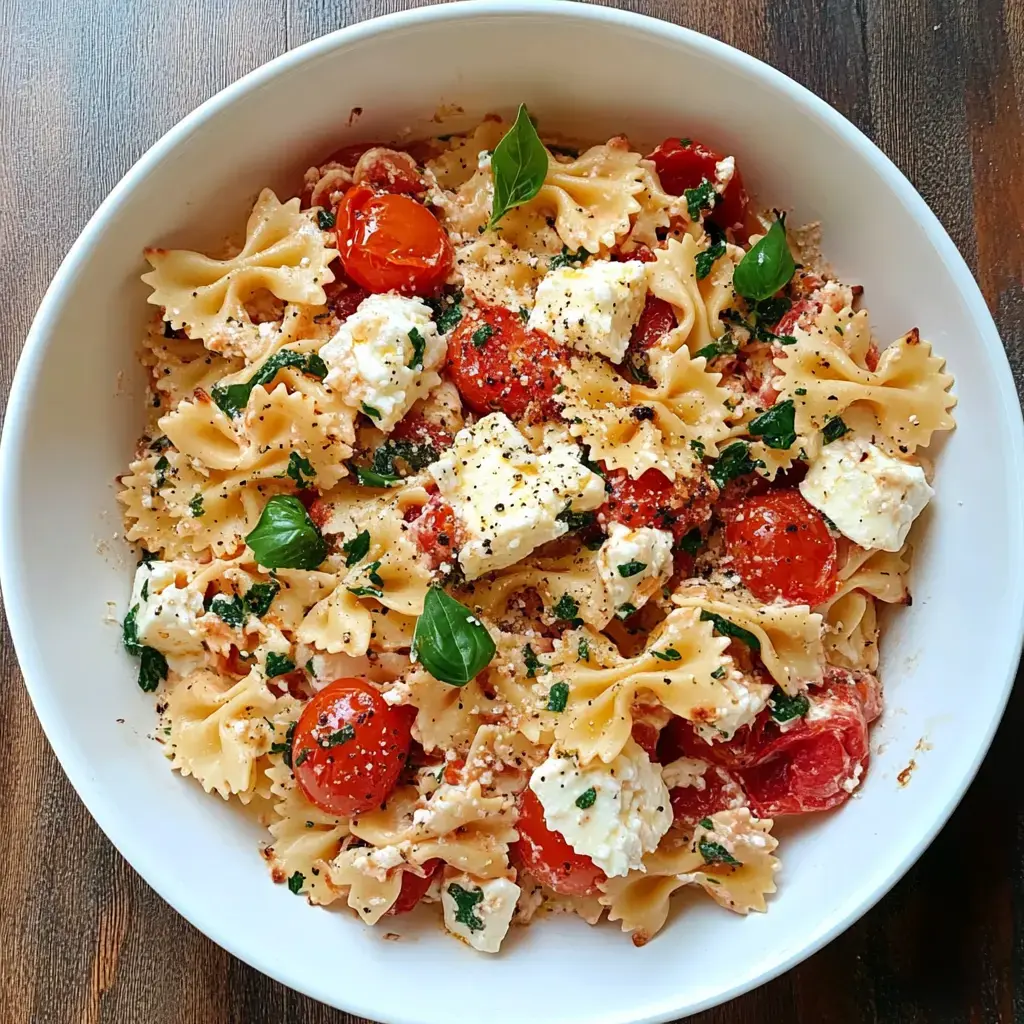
left=142, top=188, right=338, bottom=354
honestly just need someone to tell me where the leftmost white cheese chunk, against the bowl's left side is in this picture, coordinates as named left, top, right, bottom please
left=128, top=561, right=206, bottom=675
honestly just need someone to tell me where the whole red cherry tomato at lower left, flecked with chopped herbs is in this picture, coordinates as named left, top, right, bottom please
left=292, top=678, right=412, bottom=817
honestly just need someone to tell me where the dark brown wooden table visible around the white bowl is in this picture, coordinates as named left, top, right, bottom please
left=0, top=0, right=1024, bottom=1024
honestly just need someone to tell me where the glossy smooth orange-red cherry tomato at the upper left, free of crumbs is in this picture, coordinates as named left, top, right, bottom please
left=336, top=185, right=454, bottom=295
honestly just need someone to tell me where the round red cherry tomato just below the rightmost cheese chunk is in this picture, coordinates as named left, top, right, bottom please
left=725, top=489, right=837, bottom=605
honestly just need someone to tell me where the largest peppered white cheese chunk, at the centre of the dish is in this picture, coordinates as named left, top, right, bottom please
left=429, top=413, right=605, bottom=580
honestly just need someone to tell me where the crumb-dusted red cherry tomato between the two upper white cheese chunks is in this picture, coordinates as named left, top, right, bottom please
left=449, top=306, right=567, bottom=420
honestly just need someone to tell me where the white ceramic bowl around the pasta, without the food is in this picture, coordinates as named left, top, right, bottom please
left=0, top=0, right=1024, bottom=1024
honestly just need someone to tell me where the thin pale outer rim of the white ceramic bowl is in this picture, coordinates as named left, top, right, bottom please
left=0, top=0, right=1024, bottom=1024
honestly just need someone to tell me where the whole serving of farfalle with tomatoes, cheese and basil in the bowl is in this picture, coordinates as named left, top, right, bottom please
left=119, top=108, right=955, bottom=953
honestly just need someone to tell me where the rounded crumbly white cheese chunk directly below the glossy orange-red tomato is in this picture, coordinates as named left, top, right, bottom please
left=319, top=292, right=445, bottom=432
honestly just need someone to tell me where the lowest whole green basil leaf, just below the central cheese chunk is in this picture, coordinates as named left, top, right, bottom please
left=413, top=585, right=496, bottom=686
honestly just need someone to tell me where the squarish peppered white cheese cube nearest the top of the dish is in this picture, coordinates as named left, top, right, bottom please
left=529, top=260, right=647, bottom=362
